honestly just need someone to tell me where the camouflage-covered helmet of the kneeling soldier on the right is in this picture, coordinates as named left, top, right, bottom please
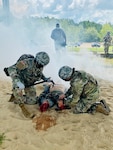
left=58, top=66, right=73, bottom=80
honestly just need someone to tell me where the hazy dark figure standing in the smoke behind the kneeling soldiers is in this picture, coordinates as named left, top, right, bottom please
left=51, top=23, right=66, bottom=52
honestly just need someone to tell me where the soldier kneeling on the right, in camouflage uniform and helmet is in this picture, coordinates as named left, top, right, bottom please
left=59, top=66, right=109, bottom=115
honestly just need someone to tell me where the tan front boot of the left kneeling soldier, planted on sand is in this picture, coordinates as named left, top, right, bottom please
left=19, top=103, right=35, bottom=118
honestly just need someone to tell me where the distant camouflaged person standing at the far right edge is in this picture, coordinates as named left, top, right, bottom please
left=104, top=32, right=112, bottom=56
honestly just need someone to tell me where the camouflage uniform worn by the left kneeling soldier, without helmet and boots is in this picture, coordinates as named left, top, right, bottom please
left=8, top=58, right=45, bottom=104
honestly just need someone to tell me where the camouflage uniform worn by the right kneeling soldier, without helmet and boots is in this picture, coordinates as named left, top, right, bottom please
left=66, top=71, right=99, bottom=113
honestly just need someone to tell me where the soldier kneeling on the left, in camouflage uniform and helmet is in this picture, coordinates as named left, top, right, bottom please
left=4, top=52, right=50, bottom=117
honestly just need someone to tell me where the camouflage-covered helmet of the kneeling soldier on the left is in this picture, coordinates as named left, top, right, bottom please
left=35, top=52, right=50, bottom=66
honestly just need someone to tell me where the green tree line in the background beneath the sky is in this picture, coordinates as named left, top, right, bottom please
left=23, top=17, right=113, bottom=43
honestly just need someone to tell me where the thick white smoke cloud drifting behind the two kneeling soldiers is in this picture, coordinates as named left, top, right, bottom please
left=0, top=16, right=113, bottom=84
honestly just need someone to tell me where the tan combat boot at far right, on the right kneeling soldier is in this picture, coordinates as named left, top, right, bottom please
left=96, top=100, right=110, bottom=115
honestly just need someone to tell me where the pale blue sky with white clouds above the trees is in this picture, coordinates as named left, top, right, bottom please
left=0, top=0, right=113, bottom=23
